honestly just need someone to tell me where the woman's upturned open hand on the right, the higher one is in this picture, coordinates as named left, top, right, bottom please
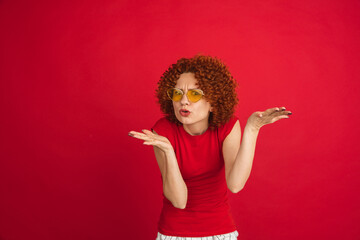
left=247, top=107, right=292, bottom=131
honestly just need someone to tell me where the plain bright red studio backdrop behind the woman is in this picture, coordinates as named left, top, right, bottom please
left=0, top=0, right=360, bottom=240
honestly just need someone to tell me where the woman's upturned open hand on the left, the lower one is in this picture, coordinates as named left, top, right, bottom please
left=129, top=129, right=174, bottom=153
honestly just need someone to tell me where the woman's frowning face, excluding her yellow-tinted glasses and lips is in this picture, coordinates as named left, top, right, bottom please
left=173, top=73, right=212, bottom=128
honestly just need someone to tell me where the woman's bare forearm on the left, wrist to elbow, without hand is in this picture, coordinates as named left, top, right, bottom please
left=163, top=151, right=188, bottom=209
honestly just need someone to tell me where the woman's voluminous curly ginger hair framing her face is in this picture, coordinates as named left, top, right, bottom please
left=156, top=55, right=238, bottom=130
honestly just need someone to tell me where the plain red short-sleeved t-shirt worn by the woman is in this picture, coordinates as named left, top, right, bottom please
left=152, top=116, right=238, bottom=237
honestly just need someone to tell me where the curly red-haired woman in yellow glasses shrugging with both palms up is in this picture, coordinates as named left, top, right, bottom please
left=129, top=55, right=291, bottom=240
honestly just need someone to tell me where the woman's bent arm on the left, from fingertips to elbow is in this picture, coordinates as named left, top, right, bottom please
left=129, top=130, right=188, bottom=209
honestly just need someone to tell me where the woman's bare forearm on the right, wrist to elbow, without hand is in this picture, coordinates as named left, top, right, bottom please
left=227, top=124, right=259, bottom=193
